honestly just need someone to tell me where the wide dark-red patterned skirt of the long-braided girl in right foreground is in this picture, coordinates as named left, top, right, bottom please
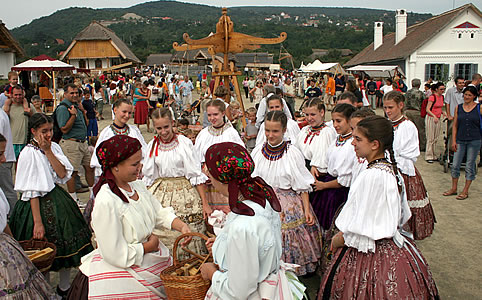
left=318, top=239, right=439, bottom=300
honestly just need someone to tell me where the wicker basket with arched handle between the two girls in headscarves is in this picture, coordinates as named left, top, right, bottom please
left=160, top=232, right=211, bottom=300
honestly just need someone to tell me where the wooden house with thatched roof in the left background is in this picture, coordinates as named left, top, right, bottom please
left=60, top=21, right=141, bottom=70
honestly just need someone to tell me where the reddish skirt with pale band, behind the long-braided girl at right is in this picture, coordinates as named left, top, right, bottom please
left=402, top=168, right=436, bottom=240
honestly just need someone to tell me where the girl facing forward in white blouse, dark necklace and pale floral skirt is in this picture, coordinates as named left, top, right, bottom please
left=251, top=111, right=321, bottom=275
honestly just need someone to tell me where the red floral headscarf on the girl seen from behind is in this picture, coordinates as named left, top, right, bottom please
left=206, top=142, right=281, bottom=216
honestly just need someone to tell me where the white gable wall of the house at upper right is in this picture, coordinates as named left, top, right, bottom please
left=405, top=10, right=482, bottom=87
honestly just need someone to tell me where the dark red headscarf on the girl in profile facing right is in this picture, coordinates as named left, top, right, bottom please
left=94, top=135, right=142, bottom=203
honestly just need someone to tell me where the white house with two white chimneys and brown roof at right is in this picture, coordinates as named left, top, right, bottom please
left=345, top=4, right=482, bottom=86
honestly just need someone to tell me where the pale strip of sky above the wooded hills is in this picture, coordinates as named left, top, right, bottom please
left=4, top=0, right=482, bottom=29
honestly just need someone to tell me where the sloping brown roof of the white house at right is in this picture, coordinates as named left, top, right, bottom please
left=345, top=4, right=482, bottom=67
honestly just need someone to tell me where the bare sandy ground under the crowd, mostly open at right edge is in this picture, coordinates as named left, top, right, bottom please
left=68, top=93, right=482, bottom=299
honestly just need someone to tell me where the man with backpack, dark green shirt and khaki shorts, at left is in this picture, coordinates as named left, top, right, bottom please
left=54, top=84, right=94, bottom=205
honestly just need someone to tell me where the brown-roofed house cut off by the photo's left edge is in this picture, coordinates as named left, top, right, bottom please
left=0, top=21, right=25, bottom=79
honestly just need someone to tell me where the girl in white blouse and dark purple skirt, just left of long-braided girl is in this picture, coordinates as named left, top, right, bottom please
left=311, top=103, right=356, bottom=272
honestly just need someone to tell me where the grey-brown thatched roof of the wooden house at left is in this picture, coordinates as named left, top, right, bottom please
left=60, top=21, right=141, bottom=63
